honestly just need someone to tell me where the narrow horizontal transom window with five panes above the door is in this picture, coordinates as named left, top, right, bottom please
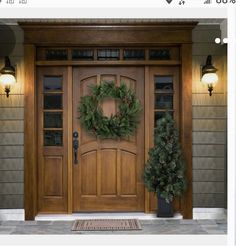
left=37, top=46, right=180, bottom=61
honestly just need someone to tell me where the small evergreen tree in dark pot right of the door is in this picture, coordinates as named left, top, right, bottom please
left=144, top=113, right=185, bottom=217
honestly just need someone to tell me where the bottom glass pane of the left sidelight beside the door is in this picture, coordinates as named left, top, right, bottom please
left=44, top=130, right=63, bottom=146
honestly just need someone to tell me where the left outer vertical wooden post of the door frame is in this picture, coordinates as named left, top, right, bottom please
left=24, top=45, right=37, bottom=220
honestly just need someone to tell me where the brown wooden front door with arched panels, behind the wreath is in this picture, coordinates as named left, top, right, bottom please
left=73, top=67, right=145, bottom=211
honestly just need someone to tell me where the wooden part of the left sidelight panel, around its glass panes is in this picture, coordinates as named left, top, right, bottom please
left=37, top=67, right=68, bottom=213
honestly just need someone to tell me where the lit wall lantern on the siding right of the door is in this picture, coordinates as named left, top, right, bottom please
left=201, top=55, right=218, bottom=96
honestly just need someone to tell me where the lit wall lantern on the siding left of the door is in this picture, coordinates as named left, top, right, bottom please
left=0, top=56, right=16, bottom=97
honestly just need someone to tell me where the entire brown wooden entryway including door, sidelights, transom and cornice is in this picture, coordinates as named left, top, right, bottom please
left=21, top=23, right=196, bottom=219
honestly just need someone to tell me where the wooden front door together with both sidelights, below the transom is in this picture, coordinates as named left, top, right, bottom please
left=37, top=63, right=181, bottom=213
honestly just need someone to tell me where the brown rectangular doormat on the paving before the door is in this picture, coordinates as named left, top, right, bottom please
left=71, top=219, right=142, bottom=231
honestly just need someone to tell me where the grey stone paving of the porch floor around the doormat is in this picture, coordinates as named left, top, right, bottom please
left=0, top=220, right=227, bottom=235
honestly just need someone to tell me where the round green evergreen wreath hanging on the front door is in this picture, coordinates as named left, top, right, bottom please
left=78, top=81, right=142, bottom=138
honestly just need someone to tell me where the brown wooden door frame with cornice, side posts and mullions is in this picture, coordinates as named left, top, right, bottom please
left=19, top=22, right=197, bottom=220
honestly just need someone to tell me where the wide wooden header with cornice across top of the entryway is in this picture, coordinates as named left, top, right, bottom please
left=20, top=23, right=196, bottom=45
